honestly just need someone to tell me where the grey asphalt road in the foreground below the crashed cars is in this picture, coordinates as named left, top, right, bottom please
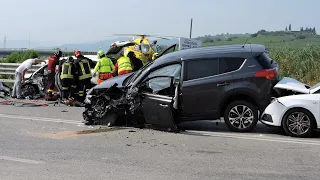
left=0, top=105, right=320, bottom=180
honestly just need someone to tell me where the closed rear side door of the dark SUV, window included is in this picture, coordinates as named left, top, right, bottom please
left=181, top=58, right=233, bottom=121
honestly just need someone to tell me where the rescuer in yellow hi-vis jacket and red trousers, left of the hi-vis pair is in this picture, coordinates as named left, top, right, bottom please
left=93, top=50, right=114, bottom=84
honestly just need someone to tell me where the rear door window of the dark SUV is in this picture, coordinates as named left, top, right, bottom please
left=184, top=58, right=219, bottom=81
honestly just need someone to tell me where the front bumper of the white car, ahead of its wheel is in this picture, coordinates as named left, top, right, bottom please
left=260, top=100, right=287, bottom=126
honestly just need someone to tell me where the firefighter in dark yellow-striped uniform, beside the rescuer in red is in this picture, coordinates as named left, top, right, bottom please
left=60, top=57, right=77, bottom=100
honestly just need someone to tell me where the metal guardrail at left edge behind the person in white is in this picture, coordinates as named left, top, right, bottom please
left=0, top=63, right=42, bottom=82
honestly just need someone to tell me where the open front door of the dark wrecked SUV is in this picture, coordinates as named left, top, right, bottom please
left=139, top=76, right=178, bottom=129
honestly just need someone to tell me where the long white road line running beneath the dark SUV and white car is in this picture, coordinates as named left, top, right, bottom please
left=183, top=131, right=320, bottom=146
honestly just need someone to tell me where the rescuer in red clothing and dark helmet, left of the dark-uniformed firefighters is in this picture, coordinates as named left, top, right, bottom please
left=46, top=50, right=62, bottom=101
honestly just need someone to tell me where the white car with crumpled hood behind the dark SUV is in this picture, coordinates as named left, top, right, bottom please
left=261, top=77, right=320, bottom=137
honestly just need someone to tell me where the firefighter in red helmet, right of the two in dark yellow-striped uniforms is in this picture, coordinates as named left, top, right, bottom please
left=74, top=51, right=94, bottom=102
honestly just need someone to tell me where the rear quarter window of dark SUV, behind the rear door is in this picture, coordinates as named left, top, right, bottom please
left=219, top=58, right=245, bottom=74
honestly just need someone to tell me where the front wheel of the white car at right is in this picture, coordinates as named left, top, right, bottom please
left=282, top=108, right=316, bottom=138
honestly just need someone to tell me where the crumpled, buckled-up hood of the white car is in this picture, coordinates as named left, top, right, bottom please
left=273, top=77, right=310, bottom=94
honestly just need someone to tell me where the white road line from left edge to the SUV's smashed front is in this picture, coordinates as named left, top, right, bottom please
left=0, top=114, right=82, bottom=125
